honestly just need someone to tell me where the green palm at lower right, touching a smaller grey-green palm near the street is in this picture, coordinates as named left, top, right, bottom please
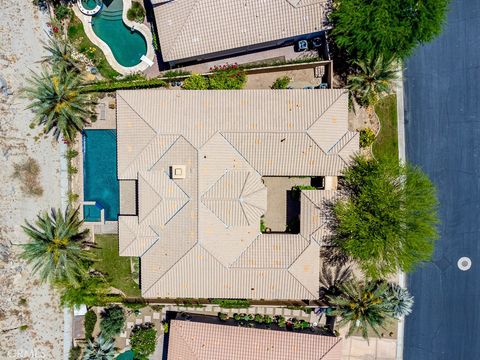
left=329, top=281, right=392, bottom=340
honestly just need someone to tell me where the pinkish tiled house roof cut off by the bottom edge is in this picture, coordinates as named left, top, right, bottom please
left=167, top=320, right=342, bottom=360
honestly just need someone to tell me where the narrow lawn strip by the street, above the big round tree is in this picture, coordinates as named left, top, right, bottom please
left=373, top=95, right=398, bottom=157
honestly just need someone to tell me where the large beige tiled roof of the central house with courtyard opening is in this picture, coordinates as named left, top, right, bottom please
left=117, top=90, right=358, bottom=299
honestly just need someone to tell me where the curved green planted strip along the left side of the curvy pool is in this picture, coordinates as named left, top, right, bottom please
left=68, top=16, right=120, bottom=79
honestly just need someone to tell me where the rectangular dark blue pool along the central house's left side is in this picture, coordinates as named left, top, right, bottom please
left=83, top=130, right=120, bottom=221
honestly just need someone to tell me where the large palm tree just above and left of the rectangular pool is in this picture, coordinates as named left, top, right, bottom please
left=23, top=68, right=95, bottom=142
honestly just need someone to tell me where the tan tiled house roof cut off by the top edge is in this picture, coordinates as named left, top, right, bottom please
left=152, top=0, right=327, bottom=61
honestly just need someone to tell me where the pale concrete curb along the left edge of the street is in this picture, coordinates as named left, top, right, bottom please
left=396, top=64, right=407, bottom=360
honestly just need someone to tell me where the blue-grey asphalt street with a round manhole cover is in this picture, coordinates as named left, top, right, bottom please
left=404, top=0, right=480, bottom=360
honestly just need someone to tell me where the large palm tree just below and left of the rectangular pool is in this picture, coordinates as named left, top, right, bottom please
left=21, top=207, right=93, bottom=286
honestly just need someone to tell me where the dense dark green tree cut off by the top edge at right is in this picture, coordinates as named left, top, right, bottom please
left=329, top=0, right=449, bottom=59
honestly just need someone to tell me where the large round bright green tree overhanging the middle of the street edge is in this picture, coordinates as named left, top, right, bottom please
left=331, top=156, right=438, bottom=279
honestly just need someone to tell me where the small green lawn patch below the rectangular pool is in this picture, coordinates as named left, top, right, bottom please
left=93, top=235, right=140, bottom=296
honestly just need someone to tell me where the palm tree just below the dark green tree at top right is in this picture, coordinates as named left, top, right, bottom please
left=347, top=56, right=397, bottom=106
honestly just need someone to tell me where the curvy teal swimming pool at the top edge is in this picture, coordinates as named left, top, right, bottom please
left=92, top=0, right=147, bottom=67
